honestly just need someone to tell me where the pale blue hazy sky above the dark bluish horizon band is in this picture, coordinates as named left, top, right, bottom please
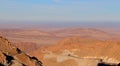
left=0, top=0, right=120, bottom=22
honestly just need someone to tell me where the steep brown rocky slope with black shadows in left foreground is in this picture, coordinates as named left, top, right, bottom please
left=0, top=36, right=42, bottom=66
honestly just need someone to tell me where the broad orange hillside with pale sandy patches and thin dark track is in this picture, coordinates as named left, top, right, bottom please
left=32, top=37, right=120, bottom=66
